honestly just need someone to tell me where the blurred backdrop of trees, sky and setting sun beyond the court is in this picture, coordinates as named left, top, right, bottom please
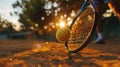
left=0, top=0, right=120, bottom=41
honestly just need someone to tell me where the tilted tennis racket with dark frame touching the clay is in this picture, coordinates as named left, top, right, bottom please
left=65, top=0, right=97, bottom=53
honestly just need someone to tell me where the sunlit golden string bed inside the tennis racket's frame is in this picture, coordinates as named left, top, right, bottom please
left=69, top=8, right=94, bottom=44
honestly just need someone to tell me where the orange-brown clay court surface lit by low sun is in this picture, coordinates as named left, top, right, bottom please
left=0, top=40, right=120, bottom=67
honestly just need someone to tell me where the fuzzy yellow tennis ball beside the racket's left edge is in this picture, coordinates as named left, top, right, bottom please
left=56, top=28, right=70, bottom=42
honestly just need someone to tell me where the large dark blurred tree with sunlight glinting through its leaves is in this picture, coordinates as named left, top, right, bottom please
left=13, top=0, right=82, bottom=32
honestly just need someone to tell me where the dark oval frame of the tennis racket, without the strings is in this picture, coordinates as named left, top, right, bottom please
left=65, top=0, right=97, bottom=53
